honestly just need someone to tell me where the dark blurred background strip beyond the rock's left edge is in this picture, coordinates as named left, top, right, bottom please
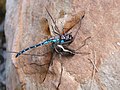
left=0, top=0, right=6, bottom=90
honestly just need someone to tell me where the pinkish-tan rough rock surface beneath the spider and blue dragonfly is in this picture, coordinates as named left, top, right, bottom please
left=5, top=0, right=120, bottom=90
